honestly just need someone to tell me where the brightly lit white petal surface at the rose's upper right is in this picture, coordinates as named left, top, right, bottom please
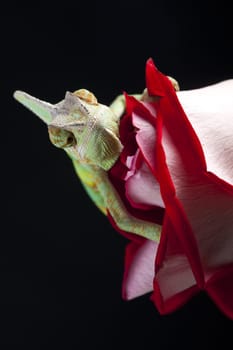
left=177, top=79, right=233, bottom=184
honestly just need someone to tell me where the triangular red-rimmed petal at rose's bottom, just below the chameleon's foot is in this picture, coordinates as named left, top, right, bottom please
left=151, top=216, right=199, bottom=314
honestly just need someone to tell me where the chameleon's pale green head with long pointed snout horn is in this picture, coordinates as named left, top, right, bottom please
left=14, top=89, right=122, bottom=170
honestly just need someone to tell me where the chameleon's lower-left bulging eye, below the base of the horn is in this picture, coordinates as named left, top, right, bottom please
left=48, top=125, right=76, bottom=148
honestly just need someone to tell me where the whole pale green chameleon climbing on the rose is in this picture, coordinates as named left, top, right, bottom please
left=14, top=77, right=179, bottom=241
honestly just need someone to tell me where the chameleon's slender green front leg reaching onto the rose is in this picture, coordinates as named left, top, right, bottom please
left=95, top=170, right=161, bottom=242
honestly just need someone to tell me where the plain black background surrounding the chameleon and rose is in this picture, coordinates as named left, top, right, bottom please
left=0, top=0, right=233, bottom=350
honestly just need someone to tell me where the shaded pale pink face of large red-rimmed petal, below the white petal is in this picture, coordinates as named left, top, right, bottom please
left=163, top=123, right=233, bottom=269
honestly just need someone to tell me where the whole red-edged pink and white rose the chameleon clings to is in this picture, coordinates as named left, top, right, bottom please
left=109, top=59, right=233, bottom=318
